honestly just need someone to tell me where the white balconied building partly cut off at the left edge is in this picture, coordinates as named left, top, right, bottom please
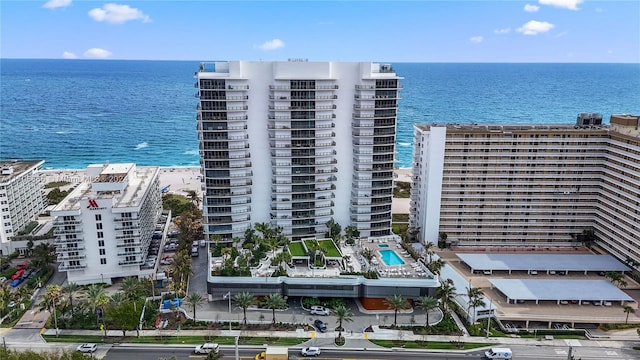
left=0, top=160, right=47, bottom=255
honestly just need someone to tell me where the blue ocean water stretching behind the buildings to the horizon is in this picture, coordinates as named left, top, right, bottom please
left=0, top=59, right=640, bottom=169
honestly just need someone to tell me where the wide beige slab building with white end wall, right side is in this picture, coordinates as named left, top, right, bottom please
left=410, top=113, right=640, bottom=268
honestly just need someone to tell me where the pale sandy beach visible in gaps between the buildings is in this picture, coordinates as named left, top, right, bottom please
left=42, top=167, right=411, bottom=214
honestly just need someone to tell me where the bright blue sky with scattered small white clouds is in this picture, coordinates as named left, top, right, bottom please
left=0, top=0, right=640, bottom=63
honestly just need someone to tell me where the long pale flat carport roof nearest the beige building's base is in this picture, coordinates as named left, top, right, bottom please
left=456, top=253, right=630, bottom=271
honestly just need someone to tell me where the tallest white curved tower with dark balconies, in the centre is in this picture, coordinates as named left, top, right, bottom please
left=196, top=59, right=400, bottom=241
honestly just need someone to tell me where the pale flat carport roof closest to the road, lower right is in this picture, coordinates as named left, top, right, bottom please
left=489, top=279, right=634, bottom=301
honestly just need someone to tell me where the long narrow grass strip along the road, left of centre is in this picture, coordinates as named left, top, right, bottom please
left=42, top=334, right=309, bottom=346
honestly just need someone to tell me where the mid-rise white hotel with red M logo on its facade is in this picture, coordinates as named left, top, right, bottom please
left=51, top=163, right=162, bottom=284
